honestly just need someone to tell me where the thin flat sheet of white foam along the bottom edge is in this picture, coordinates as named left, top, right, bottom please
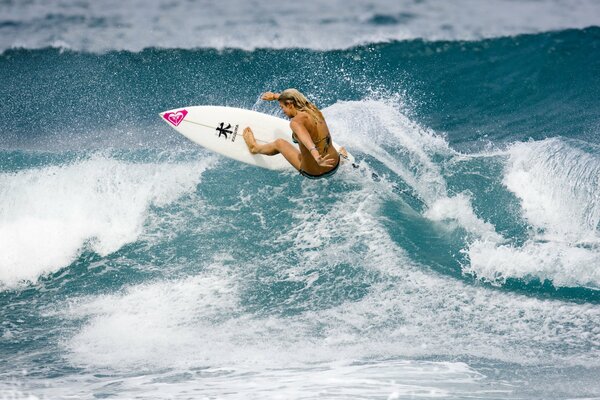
left=0, top=360, right=500, bottom=400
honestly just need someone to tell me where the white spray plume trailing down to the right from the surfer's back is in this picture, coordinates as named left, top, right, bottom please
left=325, top=98, right=502, bottom=242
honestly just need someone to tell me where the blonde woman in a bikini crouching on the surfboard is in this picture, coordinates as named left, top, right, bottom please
left=244, top=89, right=344, bottom=179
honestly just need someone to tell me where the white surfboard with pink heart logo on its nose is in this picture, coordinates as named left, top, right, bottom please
left=160, top=106, right=354, bottom=170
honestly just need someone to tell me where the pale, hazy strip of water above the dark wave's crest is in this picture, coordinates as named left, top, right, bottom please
left=0, top=0, right=600, bottom=51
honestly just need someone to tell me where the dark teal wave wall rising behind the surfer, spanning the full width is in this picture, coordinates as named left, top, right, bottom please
left=0, top=28, right=600, bottom=151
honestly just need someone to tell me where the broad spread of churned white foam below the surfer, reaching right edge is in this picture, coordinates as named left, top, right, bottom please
left=58, top=177, right=600, bottom=390
